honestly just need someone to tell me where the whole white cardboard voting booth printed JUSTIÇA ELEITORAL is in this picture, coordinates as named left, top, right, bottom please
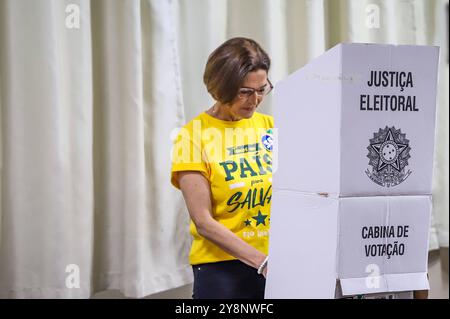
left=266, top=44, right=439, bottom=298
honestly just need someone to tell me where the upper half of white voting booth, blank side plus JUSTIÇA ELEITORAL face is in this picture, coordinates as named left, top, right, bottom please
left=273, top=44, right=439, bottom=197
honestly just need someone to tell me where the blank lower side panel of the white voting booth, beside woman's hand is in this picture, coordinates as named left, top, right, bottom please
left=265, top=191, right=338, bottom=299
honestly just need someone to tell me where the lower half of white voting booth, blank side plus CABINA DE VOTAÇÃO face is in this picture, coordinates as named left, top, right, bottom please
left=265, top=190, right=431, bottom=298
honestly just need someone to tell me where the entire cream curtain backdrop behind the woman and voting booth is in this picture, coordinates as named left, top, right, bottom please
left=0, top=0, right=449, bottom=298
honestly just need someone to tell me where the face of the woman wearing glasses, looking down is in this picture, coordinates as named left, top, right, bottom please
left=229, top=70, right=270, bottom=119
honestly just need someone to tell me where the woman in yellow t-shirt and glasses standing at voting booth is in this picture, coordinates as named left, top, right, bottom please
left=171, top=38, right=273, bottom=299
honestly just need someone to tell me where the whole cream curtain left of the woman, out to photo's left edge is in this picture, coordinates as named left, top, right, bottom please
left=0, top=0, right=192, bottom=298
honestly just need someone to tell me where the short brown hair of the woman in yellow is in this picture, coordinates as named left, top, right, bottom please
left=203, top=38, right=270, bottom=104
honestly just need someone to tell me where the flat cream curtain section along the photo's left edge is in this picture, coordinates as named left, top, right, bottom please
left=0, top=1, right=93, bottom=298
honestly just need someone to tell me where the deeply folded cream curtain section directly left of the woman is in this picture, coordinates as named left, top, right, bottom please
left=91, top=0, right=192, bottom=297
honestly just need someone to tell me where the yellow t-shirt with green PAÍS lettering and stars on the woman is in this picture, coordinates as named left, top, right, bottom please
left=171, top=112, right=273, bottom=265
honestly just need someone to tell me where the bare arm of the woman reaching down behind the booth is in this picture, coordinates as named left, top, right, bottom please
left=178, top=171, right=266, bottom=275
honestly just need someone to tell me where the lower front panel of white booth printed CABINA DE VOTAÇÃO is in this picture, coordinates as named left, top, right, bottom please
left=338, top=196, right=431, bottom=279
